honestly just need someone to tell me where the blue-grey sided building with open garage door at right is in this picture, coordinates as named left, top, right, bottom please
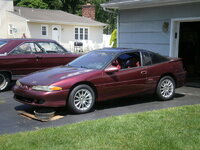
left=101, top=0, right=200, bottom=77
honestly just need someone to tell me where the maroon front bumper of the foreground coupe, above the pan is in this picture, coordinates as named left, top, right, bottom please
left=13, top=85, right=69, bottom=107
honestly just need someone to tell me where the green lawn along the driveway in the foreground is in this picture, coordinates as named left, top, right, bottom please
left=0, top=105, right=200, bottom=150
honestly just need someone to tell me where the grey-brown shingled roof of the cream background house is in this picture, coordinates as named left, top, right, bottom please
left=11, top=7, right=106, bottom=26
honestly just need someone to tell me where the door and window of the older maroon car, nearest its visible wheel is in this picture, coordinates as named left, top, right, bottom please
left=7, top=42, right=38, bottom=75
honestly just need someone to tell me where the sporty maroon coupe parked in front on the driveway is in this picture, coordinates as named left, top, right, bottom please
left=13, top=49, right=186, bottom=113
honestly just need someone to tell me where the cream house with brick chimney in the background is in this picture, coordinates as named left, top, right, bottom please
left=0, top=0, right=106, bottom=51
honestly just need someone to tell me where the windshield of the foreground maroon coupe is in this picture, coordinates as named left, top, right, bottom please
left=67, top=51, right=115, bottom=69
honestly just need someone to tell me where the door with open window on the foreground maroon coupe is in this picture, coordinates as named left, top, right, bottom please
left=102, top=52, right=147, bottom=99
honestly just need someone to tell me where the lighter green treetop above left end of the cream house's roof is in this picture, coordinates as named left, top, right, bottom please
left=17, top=0, right=48, bottom=9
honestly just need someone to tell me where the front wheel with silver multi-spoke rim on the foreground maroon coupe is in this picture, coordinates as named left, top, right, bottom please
left=68, top=84, right=95, bottom=114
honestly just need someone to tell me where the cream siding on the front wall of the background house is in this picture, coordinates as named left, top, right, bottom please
left=27, top=22, right=103, bottom=52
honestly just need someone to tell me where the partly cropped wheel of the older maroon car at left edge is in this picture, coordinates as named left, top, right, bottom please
left=0, top=72, right=11, bottom=92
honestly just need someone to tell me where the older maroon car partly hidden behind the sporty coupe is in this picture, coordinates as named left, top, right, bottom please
left=0, top=39, right=78, bottom=91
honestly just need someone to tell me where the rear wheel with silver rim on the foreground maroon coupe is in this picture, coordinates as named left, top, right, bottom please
left=156, top=76, right=176, bottom=101
